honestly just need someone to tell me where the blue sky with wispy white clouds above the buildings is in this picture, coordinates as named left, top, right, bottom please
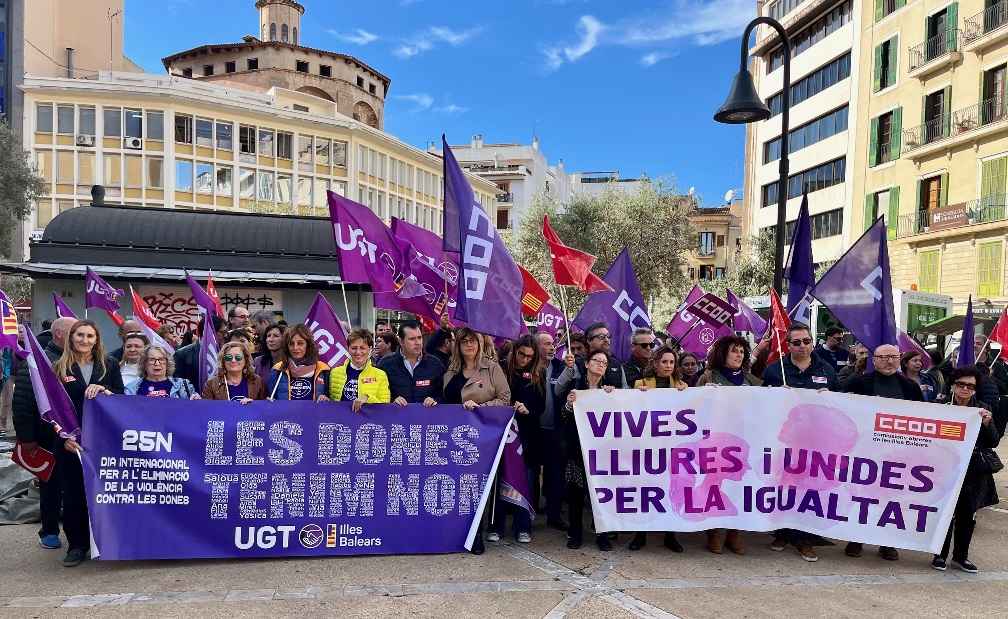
left=125, top=0, right=756, bottom=206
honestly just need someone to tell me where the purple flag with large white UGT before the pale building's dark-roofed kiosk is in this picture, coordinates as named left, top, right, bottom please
left=329, top=192, right=406, bottom=292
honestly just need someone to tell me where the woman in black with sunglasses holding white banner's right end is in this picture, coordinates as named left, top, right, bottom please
left=931, top=365, right=1001, bottom=574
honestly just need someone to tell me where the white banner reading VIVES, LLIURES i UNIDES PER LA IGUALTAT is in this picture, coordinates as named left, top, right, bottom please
left=575, top=387, right=981, bottom=552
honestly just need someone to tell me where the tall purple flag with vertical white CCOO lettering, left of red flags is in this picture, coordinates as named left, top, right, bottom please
left=442, top=135, right=524, bottom=340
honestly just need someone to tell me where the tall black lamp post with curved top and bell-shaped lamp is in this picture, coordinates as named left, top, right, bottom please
left=714, top=16, right=791, bottom=294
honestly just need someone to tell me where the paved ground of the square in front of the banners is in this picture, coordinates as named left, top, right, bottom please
left=0, top=431, right=1008, bottom=619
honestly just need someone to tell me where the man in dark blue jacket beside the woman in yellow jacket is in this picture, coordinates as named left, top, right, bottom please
left=378, top=321, right=448, bottom=407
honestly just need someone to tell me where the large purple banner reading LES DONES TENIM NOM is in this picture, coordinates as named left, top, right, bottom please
left=84, top=395, right=514, bottom=560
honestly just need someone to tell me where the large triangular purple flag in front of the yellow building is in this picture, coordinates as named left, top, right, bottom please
left=809, top=218, right=899, bottom=368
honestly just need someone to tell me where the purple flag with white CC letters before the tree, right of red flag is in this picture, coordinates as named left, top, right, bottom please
left=574, top=246, right=651, bottom=363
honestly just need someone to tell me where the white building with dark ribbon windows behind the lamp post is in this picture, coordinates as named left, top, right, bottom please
left=743, top=0, right=870, bottom=272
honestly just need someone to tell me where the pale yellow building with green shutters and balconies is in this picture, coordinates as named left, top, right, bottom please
left=851, top=0, right=1008, bottom=308
